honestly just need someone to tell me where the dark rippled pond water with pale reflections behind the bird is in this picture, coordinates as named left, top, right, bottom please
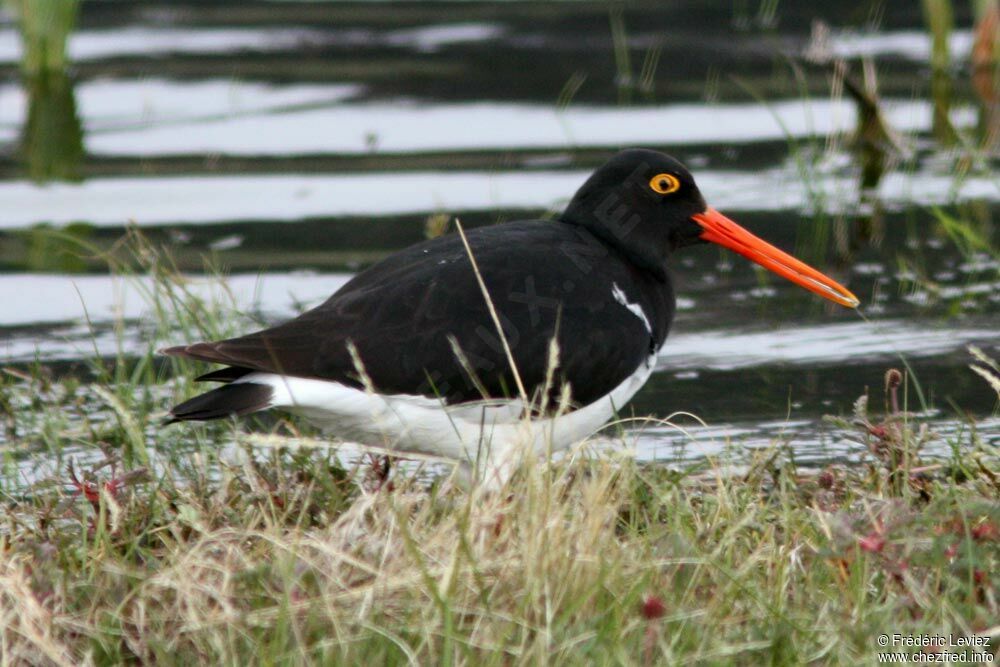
left=0, top=0, right=1000, bottom=480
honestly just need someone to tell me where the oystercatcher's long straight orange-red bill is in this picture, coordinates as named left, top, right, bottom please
left=691, top=208, right=861, bottom=308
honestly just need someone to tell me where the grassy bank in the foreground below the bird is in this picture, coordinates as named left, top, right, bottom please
left=0, top=239, right=1000, bottom=665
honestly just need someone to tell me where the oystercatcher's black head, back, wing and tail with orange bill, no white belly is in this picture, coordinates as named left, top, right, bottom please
left=165, top=149, right=857, bottom=428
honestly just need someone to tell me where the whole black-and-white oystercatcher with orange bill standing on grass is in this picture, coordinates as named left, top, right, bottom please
left=163, top=148, right=859, bottom=484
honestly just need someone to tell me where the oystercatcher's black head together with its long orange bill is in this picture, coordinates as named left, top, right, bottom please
left=561, top=148, right=859, bottom=308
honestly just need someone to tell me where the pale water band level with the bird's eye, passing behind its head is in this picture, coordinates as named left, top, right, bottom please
left=0, top=167, right=1000, bottom=231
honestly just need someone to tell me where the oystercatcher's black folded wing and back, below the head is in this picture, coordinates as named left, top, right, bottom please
left=165, top=222, right=674, bottom=405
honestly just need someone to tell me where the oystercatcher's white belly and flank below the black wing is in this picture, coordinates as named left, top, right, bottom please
left=237, top=355, right=656, bottom=481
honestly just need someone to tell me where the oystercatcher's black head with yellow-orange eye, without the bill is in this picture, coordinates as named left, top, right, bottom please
left=561, top=148, right=707, bottom=277
